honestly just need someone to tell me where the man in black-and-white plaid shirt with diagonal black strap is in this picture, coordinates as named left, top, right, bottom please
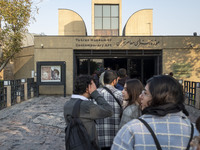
left=97, top=70, right=123, bottom=150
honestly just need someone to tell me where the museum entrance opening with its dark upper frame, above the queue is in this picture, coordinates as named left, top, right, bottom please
left=74, top=51, right=162, bottom=84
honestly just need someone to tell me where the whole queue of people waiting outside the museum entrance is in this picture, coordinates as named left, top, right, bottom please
left=64, top=69, right=200, bottom=150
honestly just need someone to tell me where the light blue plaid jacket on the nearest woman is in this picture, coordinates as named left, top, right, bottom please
left=112, top=112, right=199, bottom=150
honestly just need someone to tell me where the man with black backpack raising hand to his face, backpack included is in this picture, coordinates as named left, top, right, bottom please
left=64, top=75, right=113, bottom=150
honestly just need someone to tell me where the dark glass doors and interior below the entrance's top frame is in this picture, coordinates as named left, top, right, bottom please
left=77, top=57, right=157, bottom=84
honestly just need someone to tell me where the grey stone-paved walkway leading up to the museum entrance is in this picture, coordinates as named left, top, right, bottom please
left=0, top=96, right=200, bottom=150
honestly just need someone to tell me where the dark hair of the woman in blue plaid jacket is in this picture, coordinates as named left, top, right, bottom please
left=147, top=75, right=184, bottom=107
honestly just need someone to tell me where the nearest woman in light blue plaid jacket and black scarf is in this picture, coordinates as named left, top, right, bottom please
left=112, top=75, right=198, bottom=150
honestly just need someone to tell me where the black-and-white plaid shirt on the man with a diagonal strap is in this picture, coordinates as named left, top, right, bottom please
left=96, top=85, right=122, bottom=147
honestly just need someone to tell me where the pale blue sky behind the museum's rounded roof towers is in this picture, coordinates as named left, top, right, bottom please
left=28, top=0, right=200, bottom=36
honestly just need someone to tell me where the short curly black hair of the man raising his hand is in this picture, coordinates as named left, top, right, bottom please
left=73, top=75, right=93, bottom=95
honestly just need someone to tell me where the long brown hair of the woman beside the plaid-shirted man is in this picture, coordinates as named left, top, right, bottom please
left=125, top=79, right=144, bottom=107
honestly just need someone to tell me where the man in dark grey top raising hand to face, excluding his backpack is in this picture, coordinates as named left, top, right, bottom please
left=64, top=75, right=113, bottom=148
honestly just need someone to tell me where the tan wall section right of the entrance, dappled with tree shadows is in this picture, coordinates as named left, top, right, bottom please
left=163, top=48, right=200, bottom=81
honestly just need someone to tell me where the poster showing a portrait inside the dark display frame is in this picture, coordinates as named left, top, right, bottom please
left=41, top=66, right=61, bottom=82
